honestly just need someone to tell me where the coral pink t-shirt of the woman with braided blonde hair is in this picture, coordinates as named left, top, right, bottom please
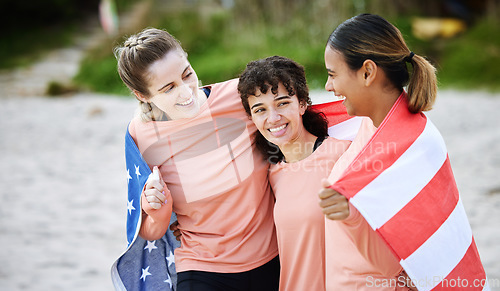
left=129, top=79, right=278, bottom=273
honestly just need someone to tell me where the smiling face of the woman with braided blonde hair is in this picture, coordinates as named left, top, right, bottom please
left=138, top=49, right=206, bottom=120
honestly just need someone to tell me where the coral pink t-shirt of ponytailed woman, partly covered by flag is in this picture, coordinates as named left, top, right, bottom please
left=325, top=118, right=407, bottom=290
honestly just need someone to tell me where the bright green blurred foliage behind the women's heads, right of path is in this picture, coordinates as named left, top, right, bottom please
left=76, top=0, right=500, bottom=95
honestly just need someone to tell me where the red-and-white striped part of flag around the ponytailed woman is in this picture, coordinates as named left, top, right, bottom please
left=323, top=93, right=489, bottom=290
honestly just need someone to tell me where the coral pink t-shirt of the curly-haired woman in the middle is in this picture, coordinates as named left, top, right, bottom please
left=269, top=137, right=350, bottom=291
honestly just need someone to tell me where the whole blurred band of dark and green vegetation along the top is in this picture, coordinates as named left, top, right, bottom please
left=0, top=0, right=500, bottom=95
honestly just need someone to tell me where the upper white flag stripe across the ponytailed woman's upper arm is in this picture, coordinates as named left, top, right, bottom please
left=350, top=120, right=447, bottom=229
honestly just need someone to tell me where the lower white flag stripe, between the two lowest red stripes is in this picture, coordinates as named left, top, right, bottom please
left=400, top=200, right=472, bottom=290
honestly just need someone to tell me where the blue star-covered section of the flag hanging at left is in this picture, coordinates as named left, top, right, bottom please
left=111, top=130, right=180, bottom=291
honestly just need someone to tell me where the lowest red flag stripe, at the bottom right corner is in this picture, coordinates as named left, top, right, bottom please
left=433, top=239, right=489, bottom=290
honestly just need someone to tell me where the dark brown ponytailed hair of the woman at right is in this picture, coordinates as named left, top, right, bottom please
left=328, top=14, right=437, bottom=113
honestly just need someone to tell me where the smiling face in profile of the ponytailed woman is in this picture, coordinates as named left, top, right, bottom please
left=325, top=45, right=372, bottom=116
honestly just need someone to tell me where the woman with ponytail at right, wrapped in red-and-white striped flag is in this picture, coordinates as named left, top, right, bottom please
left=319, top=14, right=487, bottom=290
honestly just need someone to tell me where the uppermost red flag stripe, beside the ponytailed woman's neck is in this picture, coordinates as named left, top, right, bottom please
left=332, top=98, right=426, bottom=200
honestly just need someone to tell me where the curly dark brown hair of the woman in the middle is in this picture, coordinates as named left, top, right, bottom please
left=238, top=56, right=328, bottom=163
